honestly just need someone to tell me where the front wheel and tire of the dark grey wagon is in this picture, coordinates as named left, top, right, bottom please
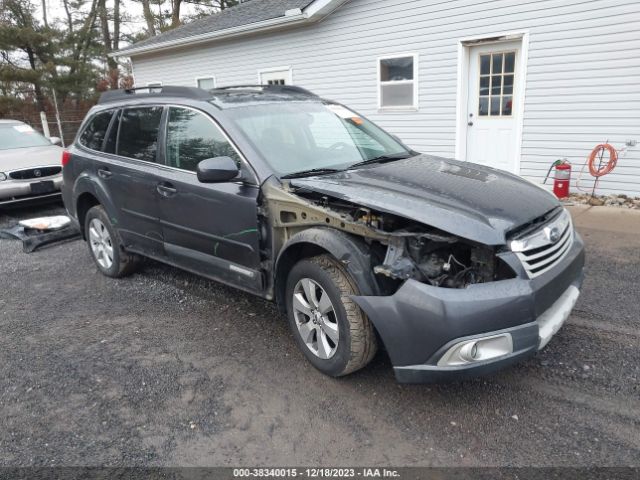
left=286, top=255, right=378, bottom=377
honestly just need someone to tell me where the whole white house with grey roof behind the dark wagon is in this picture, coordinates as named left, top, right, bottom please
left=118, top=0, right=640, bottom=195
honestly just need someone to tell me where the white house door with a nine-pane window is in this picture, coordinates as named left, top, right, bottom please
left=466, top=42, right=520, bottom=173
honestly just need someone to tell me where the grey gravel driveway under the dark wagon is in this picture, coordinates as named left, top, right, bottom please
left=0, top=201, right=640, bottom=466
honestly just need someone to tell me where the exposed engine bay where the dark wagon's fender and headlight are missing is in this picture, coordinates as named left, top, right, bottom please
left=266, top=181, right=515, bottom=288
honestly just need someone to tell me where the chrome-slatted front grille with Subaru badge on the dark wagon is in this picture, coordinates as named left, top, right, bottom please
left=510, top=210, right=574, bottom=278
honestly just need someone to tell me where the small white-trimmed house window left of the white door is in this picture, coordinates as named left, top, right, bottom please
left=378, top=54, right=418, bottom=110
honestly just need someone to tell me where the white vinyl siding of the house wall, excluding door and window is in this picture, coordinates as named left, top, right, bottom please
left=133, top=0, right=640, bottom=195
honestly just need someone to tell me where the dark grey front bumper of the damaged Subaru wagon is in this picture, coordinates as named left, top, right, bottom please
left=353, top=233, right=584, bottom=383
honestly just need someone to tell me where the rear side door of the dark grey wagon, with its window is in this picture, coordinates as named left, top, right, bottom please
left=97, top=106, right=164, bottom=257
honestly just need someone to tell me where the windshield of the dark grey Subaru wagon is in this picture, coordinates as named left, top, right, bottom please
left=228, top=102, right=413, bottom=175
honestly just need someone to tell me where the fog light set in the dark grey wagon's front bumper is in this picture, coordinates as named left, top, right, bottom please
left=438, top=333, right=513, bottom=367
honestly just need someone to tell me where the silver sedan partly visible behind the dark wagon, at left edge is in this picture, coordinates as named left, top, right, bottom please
left=0, top=120, right=63, bottom=207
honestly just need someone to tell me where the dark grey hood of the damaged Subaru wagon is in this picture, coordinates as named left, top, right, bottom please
left=291, top=155, right=560, bottom=245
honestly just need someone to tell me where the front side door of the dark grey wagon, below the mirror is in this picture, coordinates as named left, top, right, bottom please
left=158, top=107, right=263, bottom=292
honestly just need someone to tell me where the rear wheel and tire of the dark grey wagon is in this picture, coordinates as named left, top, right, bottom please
left=84, top=205, right=139, bottom=278
